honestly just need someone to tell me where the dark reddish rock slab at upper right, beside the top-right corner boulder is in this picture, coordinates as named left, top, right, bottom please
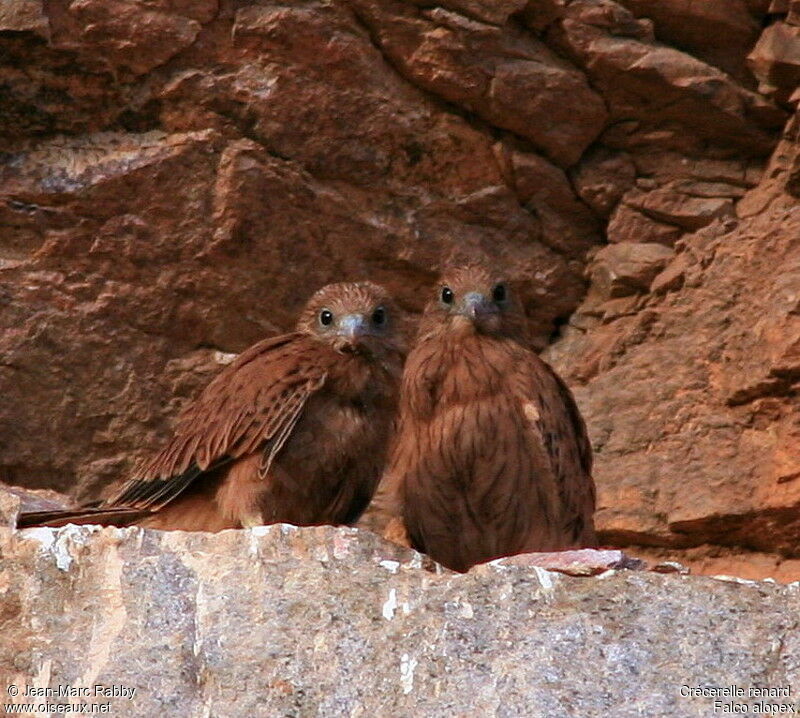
left=549, top=0, right=784, bottom=154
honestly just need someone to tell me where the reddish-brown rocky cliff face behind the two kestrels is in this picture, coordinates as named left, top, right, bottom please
left=0, top=0, right=800, bottom=578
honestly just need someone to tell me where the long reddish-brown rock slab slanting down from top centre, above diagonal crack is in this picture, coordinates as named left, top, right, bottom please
left=351, top=0, right=606, bottom=165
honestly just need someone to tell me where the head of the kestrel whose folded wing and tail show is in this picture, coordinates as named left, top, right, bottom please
left=297, top=282, right=402, bottom=354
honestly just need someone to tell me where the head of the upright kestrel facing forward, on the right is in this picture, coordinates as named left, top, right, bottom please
left=421, top=264, right=524, bottom=342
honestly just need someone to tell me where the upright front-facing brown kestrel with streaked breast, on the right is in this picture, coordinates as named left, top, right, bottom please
left=379, top=265, right=595, bottom=571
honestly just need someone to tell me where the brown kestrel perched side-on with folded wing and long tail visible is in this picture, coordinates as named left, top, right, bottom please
left=18, top=282, right=404, bottom=531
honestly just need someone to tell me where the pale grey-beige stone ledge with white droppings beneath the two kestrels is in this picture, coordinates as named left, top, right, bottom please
left=0, top=526, right=800, bottom=718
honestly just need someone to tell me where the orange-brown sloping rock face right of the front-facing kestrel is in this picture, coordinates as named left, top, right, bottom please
left=549, top=202, right=800, bottom=556
